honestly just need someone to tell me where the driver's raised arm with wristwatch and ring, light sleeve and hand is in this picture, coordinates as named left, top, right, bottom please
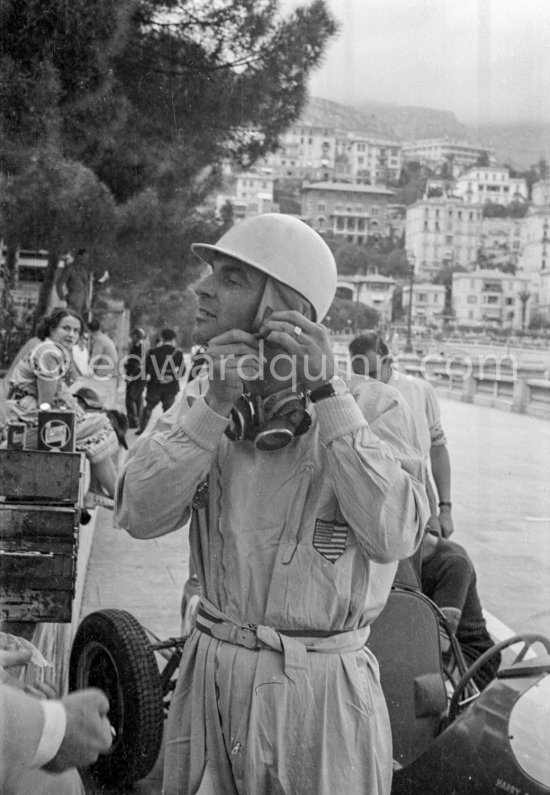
left=260, top=311, right=429, bottom=563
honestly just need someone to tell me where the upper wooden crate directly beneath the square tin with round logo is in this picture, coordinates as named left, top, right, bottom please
left=0, top=450, right=84, bottom=504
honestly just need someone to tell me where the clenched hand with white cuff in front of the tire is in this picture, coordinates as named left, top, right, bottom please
left=44, top=688, right=113, bottom=773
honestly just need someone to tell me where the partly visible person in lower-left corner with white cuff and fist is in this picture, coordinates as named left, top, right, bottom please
left=0, top=649, right=112, bottom=795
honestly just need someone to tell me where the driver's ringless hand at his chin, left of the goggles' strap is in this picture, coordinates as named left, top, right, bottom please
left=204, top=329, right=260, bottom=416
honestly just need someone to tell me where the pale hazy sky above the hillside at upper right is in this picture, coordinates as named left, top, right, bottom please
left=281, top=0, right=550, bottom=124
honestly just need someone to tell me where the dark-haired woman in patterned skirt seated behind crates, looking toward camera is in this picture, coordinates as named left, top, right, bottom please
left=6, top=308, right=118, bottom=505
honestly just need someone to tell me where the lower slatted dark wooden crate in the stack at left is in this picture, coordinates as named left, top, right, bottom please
left=0, top=506, right=79, bottom=623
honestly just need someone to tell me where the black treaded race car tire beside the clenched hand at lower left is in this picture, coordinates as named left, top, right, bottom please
left=69, top=610, right=164, bottom=787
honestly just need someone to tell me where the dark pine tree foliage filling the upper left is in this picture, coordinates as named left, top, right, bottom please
left=0, top=0, right=336, bottom=326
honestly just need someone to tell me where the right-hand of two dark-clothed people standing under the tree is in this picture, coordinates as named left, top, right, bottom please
left=136, top=328, right=185, bottom=436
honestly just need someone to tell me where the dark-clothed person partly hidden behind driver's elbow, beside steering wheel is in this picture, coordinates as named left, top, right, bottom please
left=421, top=532, right=501, bottom=690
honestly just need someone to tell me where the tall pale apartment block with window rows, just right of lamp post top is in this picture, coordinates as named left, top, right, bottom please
left=405, top=196, right=482, bottom=280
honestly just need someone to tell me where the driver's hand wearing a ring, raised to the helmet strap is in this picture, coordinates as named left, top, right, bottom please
left=260, top=310, right=335, bottom=389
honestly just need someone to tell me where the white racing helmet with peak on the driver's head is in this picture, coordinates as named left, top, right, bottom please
left=191, top=213, right=336, bottom=321
